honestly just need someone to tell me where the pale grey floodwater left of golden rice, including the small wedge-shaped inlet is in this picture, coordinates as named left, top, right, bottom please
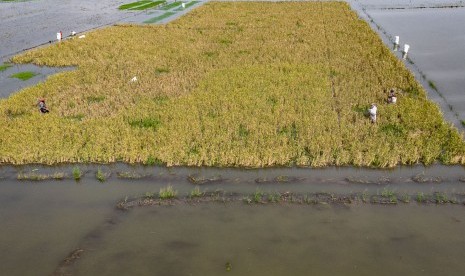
left=0, top=0, right=204, bottom=98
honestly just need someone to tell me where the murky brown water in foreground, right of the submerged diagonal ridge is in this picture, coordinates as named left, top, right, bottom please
left=71, top=203, right=465, bottom=275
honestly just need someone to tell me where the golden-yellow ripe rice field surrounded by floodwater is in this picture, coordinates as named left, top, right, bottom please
left=0, top=2, right=465, bottom=167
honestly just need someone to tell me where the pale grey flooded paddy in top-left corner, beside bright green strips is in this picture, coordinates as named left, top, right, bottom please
left=0, top=0, right=129, bottom=61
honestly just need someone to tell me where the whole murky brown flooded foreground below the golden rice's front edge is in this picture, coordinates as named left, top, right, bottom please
left=0, top=164, right=465, bottom=275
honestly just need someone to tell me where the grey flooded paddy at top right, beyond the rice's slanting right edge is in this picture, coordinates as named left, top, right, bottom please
left=351, top=0, right=465, bottom=129
